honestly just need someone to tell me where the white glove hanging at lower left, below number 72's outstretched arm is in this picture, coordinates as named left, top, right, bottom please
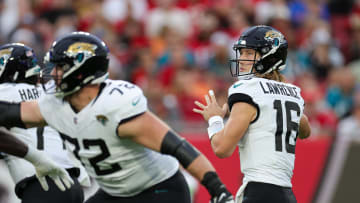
left=24, top=147, right=74, bottom=191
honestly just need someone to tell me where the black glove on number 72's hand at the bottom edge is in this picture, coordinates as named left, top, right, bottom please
left=201, top=171, right=235, bottom=203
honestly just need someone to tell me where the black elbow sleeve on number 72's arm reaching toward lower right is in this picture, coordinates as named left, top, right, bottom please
left=160, top=131, right=200, bottom=168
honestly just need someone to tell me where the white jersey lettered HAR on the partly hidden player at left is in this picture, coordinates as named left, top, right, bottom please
left=0, top=83, right=89, bottom=185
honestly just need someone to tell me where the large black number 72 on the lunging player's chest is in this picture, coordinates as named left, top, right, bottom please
left=60, top=133, right=121, bottom=176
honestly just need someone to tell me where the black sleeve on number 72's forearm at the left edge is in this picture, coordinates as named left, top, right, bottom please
left=0, top=101, right=26, bottom=129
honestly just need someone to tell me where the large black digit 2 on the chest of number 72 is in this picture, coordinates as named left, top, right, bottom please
left=84, top=139, right=121, bottom=175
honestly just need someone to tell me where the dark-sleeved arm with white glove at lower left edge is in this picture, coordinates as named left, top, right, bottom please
left=0, top=128, right=74, bottom=191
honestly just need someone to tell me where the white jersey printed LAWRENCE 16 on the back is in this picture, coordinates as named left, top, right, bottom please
left=228, top=77, right=304, bottom=187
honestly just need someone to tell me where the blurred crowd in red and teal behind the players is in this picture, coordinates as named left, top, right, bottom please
left=0, top=0, right=360, bottom=136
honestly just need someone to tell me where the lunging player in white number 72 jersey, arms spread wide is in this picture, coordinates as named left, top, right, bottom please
left=0, top=32, right=233, bottom=203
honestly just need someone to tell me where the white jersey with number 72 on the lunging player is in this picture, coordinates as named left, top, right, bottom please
left=39, top=80, right=179, bottom=196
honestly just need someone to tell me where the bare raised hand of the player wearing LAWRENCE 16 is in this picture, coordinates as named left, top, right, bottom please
left=193, top=90, right=228, bottom=121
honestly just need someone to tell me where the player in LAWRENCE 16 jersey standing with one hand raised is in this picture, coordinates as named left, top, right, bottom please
left=194, top=26, right=310, bottom=203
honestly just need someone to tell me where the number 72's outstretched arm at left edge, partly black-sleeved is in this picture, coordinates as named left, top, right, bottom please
left=0, top=101, right=46, bottom=128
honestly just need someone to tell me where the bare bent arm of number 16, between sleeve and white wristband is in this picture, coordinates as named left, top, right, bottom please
left=211, top=102, right=257, bottom=158
